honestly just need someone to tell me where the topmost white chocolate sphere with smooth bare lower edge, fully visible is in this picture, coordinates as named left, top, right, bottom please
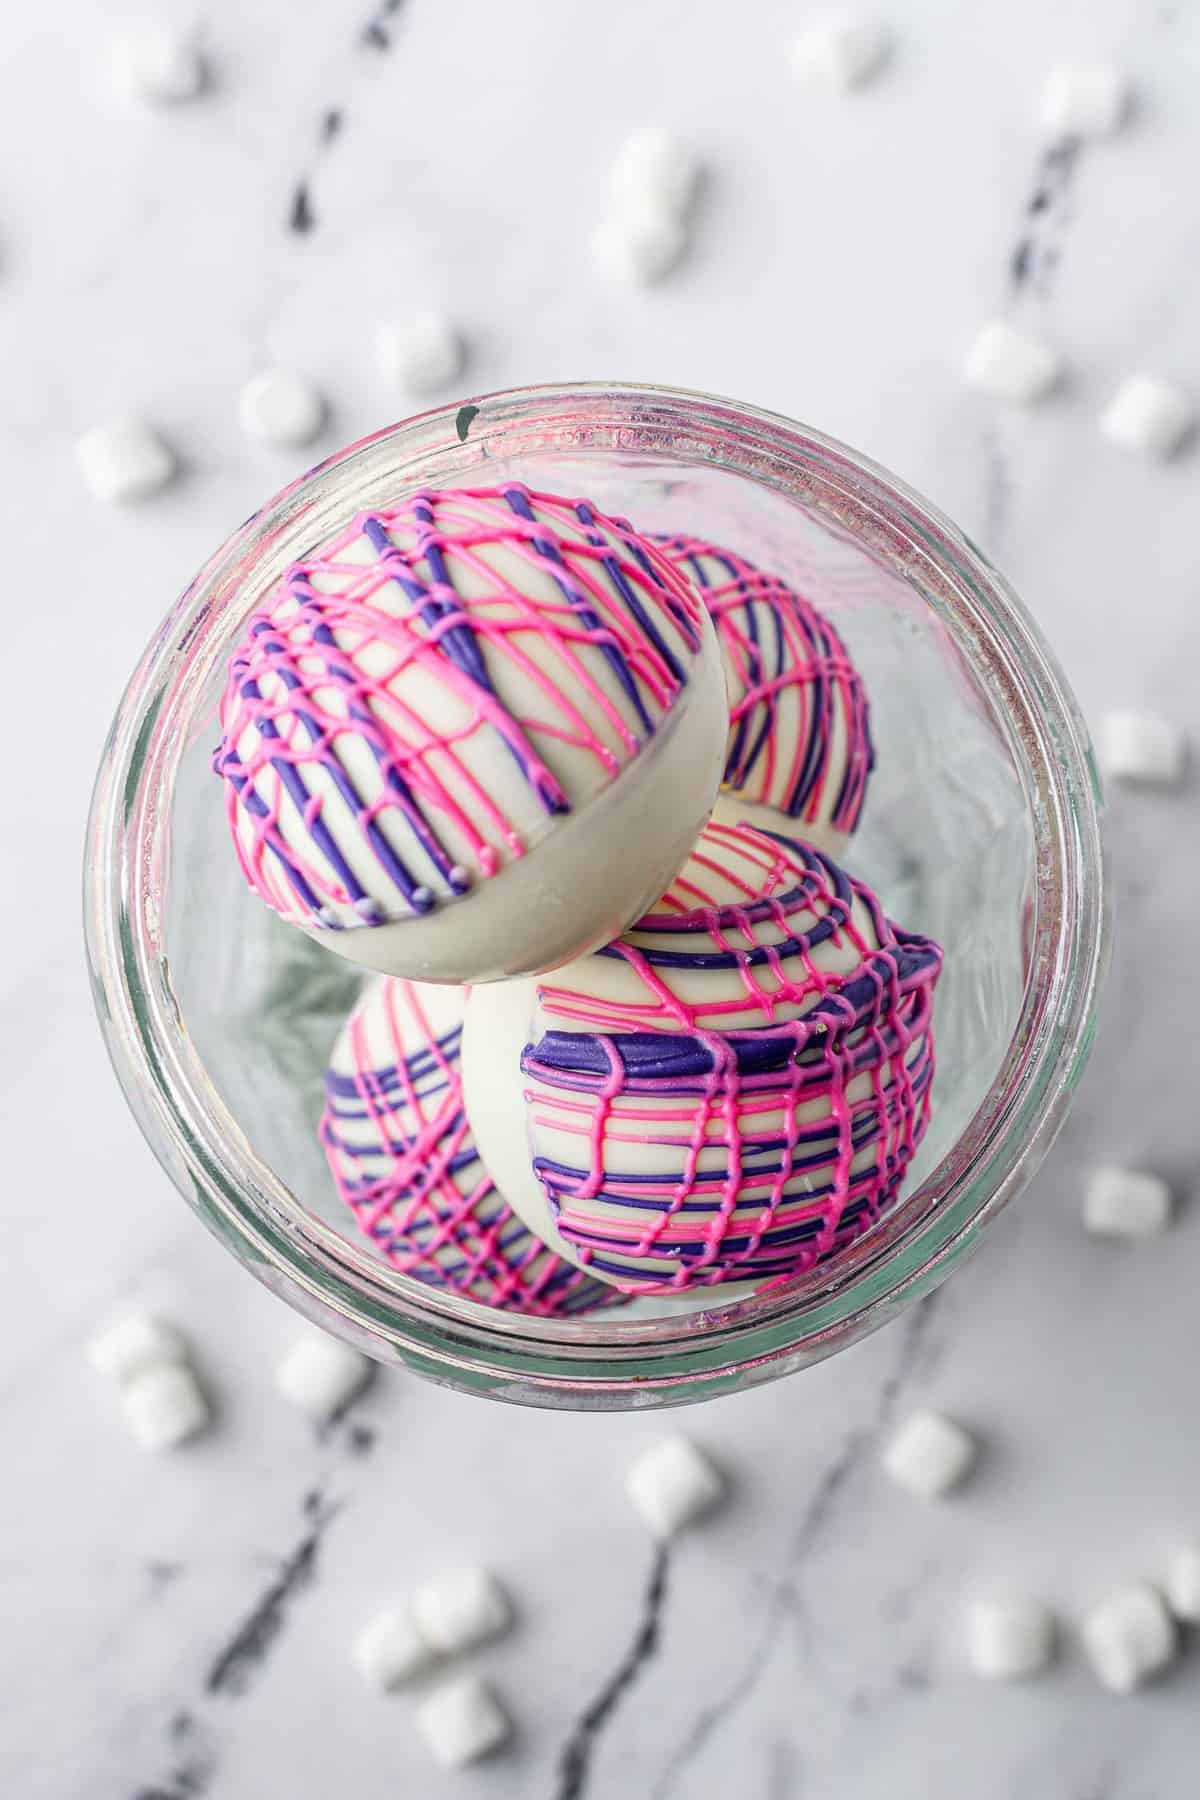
left=216, top=482, right=727, bottom=983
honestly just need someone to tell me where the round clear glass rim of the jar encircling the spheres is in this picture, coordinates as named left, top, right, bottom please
left=85, top=383, right=1106, bottom=1408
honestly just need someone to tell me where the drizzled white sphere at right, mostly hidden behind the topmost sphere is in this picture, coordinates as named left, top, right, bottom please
left=658, top=536, right=874, bottom=857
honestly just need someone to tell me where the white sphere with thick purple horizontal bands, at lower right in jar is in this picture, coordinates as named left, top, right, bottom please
left=462, top=817, right=941, bottom=1294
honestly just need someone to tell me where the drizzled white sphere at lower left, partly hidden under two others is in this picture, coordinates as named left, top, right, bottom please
left=320, top=977, right=617, bottom=1318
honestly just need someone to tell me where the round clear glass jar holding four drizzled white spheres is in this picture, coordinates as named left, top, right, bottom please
left=86, top=385, right=1106, bottom=1409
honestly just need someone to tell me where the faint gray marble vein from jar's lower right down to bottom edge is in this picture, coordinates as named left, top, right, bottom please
left=651, top=1294, right=939, bottom=1800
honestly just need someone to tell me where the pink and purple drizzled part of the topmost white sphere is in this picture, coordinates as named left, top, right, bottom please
left=216, top=484, right=703, bottom=927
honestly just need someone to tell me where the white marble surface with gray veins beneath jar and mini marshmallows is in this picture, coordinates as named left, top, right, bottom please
left=0, top=0, right=1200, bottom=1800
